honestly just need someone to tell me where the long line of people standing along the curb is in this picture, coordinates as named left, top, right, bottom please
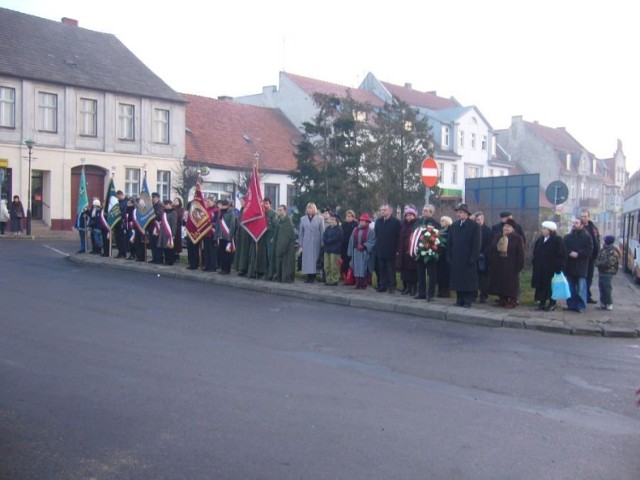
left=77, top=191, right=620, bottom=312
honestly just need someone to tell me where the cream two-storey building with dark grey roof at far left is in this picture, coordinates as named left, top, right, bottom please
left=0, top=8, right=186, bottom=230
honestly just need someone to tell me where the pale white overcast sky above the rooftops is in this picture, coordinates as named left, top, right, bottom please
left=5, top=0, right=640, bottom=173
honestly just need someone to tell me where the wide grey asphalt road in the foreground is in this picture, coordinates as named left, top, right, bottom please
left=0, top=240, right=640, bottom=480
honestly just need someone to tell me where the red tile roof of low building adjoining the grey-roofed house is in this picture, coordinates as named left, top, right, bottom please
left=183, top=94, right=301, bottom=173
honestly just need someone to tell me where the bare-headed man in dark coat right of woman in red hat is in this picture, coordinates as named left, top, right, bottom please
left=374, top=204, right=402, bottom=293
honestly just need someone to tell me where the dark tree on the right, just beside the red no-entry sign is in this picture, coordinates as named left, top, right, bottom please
left=372, top=97, right=433, bottom=206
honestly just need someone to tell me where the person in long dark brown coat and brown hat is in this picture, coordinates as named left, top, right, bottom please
left=488, top=218, right=524, bottom=308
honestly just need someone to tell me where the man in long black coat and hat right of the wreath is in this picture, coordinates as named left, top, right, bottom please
left=447, top=203, right=482, bottom=308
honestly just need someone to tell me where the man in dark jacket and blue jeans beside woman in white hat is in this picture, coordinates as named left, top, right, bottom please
left=564, top=218, right=593, bottom=312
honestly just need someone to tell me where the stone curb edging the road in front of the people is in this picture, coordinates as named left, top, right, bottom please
left=66, top=254, right=640, bottom=338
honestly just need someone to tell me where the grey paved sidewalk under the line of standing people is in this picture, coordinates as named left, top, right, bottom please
left=69, top=254, right=640, bottom=338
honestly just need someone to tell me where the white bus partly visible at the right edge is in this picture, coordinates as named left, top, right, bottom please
left=622, top=170, right=640, bottom=283
